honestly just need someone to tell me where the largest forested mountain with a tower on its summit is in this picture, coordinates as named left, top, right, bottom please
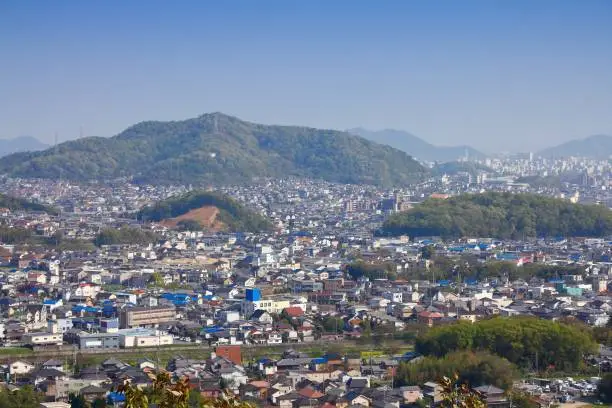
left=0, top=113, right=426, bottom=186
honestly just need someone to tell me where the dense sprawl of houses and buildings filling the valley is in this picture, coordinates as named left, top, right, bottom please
left=0, top=162, right=612, bottom=408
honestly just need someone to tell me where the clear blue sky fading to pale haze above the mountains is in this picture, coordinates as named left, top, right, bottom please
left=0, top=0, right=612, bottom=151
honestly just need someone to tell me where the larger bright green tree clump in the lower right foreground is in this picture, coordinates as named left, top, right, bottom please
left=416, top=317, right=596, bottom=371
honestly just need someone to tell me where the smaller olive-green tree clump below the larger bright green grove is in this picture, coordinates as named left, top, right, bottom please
left=396, top=350, right=520, bottom=389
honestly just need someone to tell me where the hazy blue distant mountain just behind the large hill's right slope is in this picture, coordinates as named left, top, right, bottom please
left=347, top=128, right=486, bottom=162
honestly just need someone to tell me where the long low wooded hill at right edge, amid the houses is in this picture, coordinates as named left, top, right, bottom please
left=382, top=192, right=612, bottom=238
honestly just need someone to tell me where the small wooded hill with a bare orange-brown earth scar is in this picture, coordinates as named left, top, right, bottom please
left=137, top=191, right=272, bottom=232
